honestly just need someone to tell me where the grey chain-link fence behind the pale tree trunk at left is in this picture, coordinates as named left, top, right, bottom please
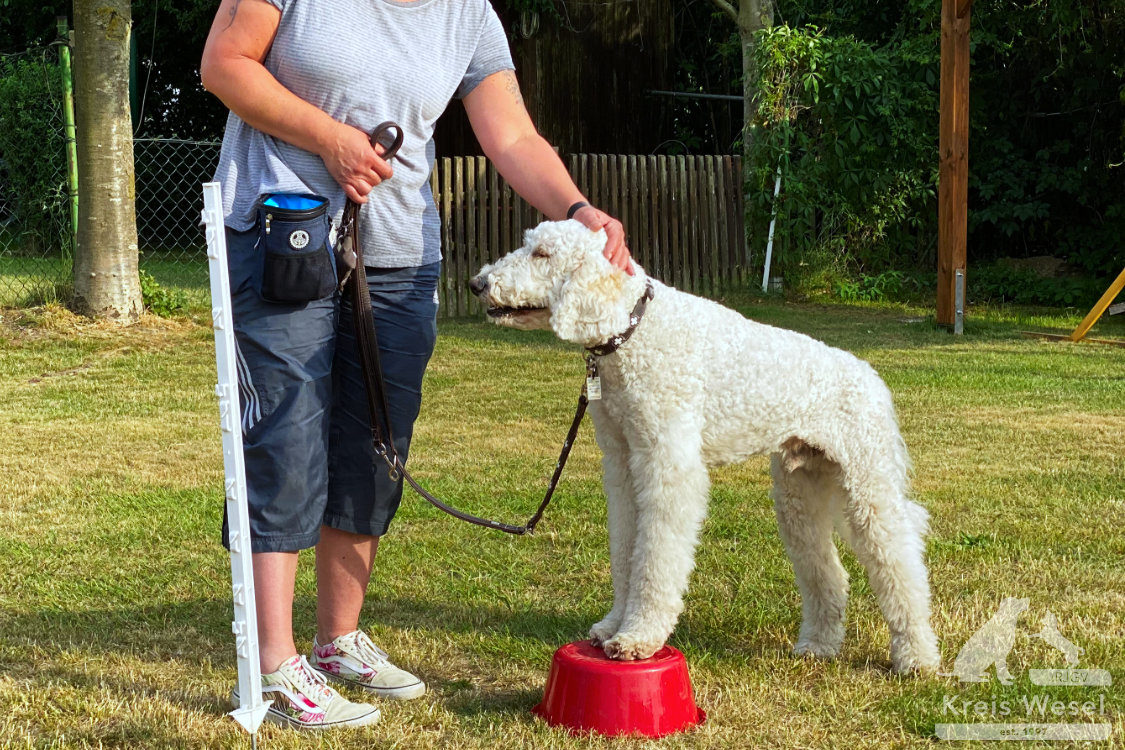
left=0, top=45, right=219, bottom=307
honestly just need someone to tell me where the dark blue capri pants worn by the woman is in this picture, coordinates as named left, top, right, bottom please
left=223, top=228, right=441, bottom=552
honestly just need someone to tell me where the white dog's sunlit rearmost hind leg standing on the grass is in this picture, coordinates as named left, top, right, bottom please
left=840, top=462, right=941, bottom=672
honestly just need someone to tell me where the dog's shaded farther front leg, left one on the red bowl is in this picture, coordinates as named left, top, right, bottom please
left=590, top=412, right=637, bottom=645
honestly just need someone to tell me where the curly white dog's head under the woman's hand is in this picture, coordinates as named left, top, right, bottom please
left=469, top=220, right=645, bottom=346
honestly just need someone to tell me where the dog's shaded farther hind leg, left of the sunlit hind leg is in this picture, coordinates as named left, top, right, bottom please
left=770, top=439, right=848, bottom=658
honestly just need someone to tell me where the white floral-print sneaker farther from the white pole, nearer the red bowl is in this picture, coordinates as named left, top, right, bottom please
left=309, top=630, right=425, bottom=701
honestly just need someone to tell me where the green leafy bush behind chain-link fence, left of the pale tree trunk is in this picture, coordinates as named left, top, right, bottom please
left=0, top=58, right=72, bottom=256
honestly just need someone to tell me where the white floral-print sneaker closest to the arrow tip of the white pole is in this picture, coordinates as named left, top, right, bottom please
left=231, top=656, right=379, bottom=730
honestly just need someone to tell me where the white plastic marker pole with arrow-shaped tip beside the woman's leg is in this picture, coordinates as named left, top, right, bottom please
left=204, top=182, right=272, bottom=748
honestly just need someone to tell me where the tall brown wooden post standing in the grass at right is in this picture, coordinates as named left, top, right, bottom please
left=937, top=0, right=972, bottom=326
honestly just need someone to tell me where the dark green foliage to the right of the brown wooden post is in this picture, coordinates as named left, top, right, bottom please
left=969, top=0, right=1125, bottom=277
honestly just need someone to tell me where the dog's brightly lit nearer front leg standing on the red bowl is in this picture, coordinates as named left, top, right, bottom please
left=604, top=419, right=710, bottom=659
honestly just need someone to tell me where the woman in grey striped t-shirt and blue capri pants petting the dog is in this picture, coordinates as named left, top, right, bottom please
left=200, top=0, right=631, bottom=729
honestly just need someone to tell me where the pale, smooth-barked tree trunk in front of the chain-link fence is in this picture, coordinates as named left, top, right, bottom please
left=74, top=0, right=142, bottom=323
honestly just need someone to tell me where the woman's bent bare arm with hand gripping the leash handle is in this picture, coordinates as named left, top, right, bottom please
left=199, top=0, right=392, bottom=204
